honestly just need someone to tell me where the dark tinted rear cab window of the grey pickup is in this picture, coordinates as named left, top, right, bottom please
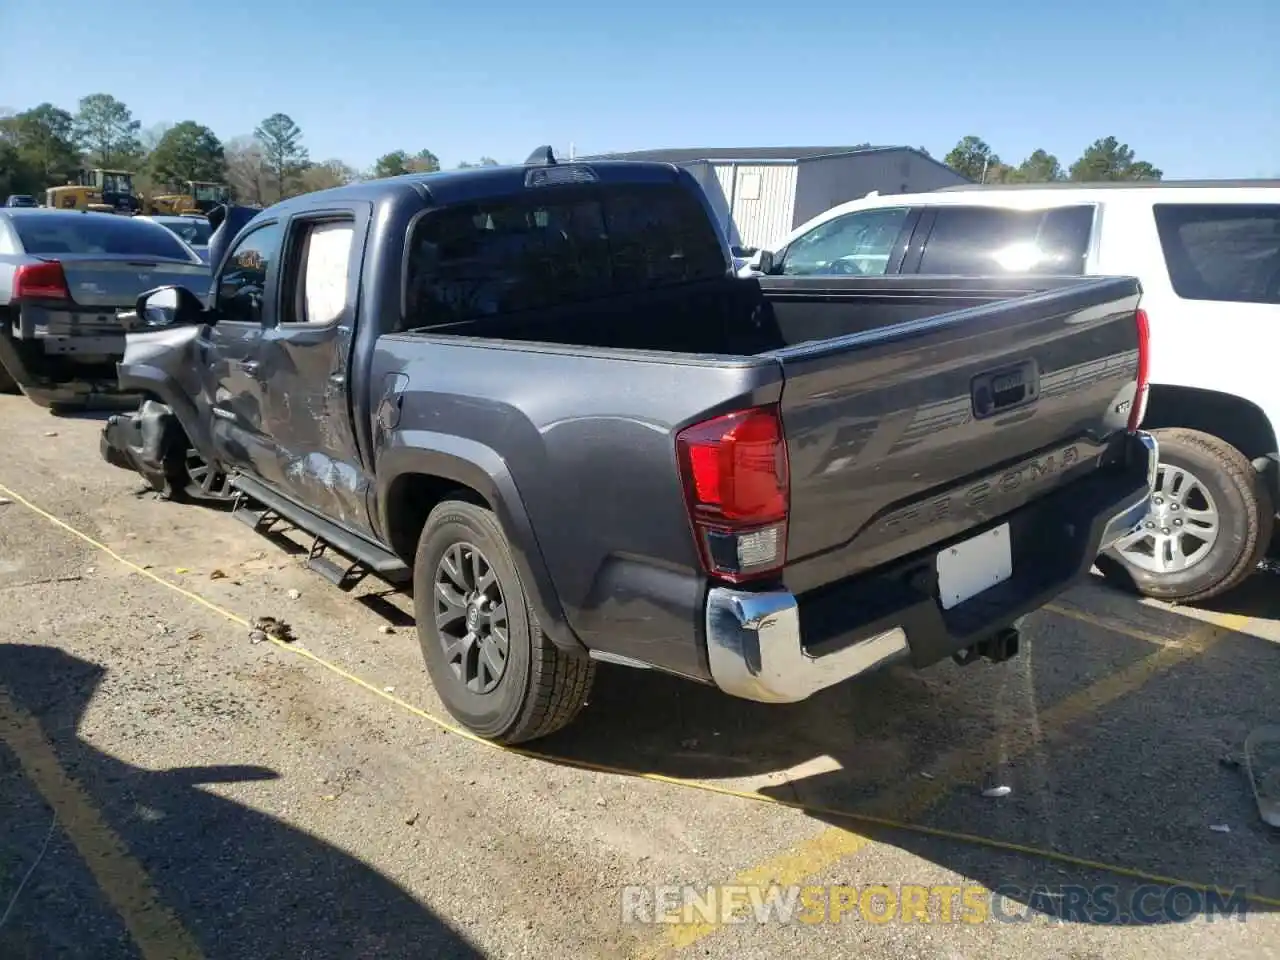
left=406, top=186, right=728, bottom=328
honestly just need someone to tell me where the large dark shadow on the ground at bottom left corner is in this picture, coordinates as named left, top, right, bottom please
left=0, top=644, right=483, bottom=960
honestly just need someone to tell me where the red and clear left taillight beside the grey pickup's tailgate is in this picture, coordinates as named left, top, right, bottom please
left=676, top=406, right=790, bottom=582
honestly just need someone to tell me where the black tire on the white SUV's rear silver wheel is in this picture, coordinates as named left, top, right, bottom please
left=1098, top=428, right=1275, bottom=603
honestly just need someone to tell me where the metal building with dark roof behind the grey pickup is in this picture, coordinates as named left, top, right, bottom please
left=579, top=147, right=969, bottom=247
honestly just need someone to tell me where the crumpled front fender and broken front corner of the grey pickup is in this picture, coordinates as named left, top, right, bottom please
left=99, top=325, right=229, bottom=500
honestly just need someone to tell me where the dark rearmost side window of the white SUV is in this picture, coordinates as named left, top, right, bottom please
left=1155, top=204, right=1280, bottom=303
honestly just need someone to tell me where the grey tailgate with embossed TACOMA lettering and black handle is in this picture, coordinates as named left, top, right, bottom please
left=773, top=278, right=1140, bottom=593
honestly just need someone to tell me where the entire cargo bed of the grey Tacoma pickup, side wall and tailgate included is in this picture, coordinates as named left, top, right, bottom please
left=384, top=271, right=1139, bottom=676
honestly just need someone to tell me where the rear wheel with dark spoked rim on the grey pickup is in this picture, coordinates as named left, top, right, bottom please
left=413, top=500, right=595, bottom=744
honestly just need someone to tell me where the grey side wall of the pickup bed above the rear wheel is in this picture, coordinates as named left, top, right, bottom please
left=374, top=335, right=781, bottom=678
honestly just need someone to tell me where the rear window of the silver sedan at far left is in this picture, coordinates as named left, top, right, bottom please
left=10, top=214, right=192, bottom=264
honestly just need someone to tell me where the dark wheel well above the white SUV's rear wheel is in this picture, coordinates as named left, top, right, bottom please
left=1142, top=384, right=1280, bottom=504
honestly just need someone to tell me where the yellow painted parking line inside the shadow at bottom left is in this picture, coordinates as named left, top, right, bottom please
left=0, top=687, right=202, bottom=960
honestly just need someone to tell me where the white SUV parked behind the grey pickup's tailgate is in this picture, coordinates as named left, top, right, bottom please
left=742, top=180, right=1280, bottom=602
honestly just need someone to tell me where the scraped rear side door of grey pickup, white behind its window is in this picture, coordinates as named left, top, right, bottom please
left=248, top=204, right=371, bottom=532
